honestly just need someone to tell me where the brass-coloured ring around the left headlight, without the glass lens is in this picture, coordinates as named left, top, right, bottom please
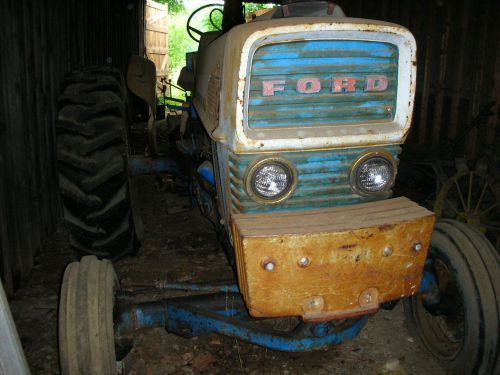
left=243, top=156, right=298, bottom=205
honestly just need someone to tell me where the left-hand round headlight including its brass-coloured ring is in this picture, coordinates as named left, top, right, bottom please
left=245, top=158, right=296, bottom=204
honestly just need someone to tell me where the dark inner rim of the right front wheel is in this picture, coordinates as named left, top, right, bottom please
left=413, top=254, right=466, bottom=361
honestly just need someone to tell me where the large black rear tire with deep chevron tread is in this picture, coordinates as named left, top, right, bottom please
left=57, top=67, right=139, bottom=259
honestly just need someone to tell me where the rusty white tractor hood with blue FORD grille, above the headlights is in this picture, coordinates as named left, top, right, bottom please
left=194, top=17, right=416, bottom=153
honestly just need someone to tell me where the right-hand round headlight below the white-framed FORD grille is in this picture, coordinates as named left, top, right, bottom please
left=351, top=152, right=395, bottom=194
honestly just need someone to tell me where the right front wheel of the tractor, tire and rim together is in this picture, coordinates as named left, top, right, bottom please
left=404, top=220, right=500, bottom=374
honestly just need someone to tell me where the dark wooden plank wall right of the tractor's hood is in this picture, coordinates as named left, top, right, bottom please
left=337, top=0, right=500, bottom=159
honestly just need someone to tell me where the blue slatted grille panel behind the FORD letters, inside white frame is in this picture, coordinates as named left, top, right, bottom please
left=248, top=40, right=398, bottom=129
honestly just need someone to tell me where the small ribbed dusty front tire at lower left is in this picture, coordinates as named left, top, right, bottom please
left=59, top=256, right=119, bottom=375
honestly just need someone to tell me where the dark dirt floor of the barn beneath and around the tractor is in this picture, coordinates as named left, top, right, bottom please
left=10, top=177, right=445, bottom=375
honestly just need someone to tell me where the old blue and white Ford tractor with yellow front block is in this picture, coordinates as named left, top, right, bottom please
left=57, top=0, right=500, bottom=374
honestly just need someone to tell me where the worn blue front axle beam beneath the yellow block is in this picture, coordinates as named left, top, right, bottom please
left=115, top=293, right=368, bottom=352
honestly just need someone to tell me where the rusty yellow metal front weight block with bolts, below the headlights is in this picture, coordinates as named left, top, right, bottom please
left=231, top=198, right=434, bottom=321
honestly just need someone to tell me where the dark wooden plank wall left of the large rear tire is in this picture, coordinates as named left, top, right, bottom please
left=0, top=0, right=144, bottom=292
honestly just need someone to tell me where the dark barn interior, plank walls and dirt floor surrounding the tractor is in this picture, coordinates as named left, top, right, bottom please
left=0, top=0, right=500, bottom=374
